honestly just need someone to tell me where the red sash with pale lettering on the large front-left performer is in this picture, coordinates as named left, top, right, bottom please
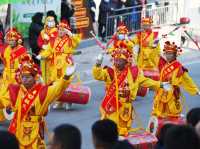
left=8, top=84, right=42, bottom=134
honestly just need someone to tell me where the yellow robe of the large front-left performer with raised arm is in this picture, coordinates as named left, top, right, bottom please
left=0, top=79, right=71, bottom=149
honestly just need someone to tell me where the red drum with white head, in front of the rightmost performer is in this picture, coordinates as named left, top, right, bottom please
left=147, top=116, right=185, bottom=135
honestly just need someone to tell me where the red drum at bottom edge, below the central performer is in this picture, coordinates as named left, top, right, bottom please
left=120, top=132, right=158, bottom=149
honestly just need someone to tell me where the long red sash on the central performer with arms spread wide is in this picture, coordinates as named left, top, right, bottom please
left=101, top=68, right=128, bottom=114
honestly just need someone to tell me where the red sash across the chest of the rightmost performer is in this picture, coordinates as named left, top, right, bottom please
left=161, top=61, right=182, bottom=81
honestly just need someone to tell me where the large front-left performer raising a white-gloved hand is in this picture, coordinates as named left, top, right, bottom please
left=0, top=55, right=75, bottom=149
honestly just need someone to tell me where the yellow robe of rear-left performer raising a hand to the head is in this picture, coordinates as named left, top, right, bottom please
left=40, top=35, right=80, bottom=84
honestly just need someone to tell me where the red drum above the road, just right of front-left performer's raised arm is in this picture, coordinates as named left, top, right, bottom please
left=58, top=84, right=91, bottom=104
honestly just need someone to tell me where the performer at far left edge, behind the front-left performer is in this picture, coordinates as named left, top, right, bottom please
left=1, top=28, right=27, bottom=84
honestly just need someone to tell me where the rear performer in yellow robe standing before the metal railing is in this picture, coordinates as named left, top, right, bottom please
left=132, top=18, right=160, bottom=70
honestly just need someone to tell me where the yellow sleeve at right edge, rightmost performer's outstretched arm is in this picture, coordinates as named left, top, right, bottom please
left=181, top=72, right=199, bottom=95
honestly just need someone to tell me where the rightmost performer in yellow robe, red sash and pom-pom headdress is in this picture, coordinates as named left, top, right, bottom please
left=152, top=41, right=200, bottom=118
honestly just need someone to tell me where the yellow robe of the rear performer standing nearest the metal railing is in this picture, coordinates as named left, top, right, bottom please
left=132, top=32, right=160, bottom=70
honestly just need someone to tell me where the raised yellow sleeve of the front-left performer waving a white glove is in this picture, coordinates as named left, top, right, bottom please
left=42, top=79, right=71, bottom=109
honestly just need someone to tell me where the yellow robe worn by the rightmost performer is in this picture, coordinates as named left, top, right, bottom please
left=152, top=61, right=199, bottom=117
